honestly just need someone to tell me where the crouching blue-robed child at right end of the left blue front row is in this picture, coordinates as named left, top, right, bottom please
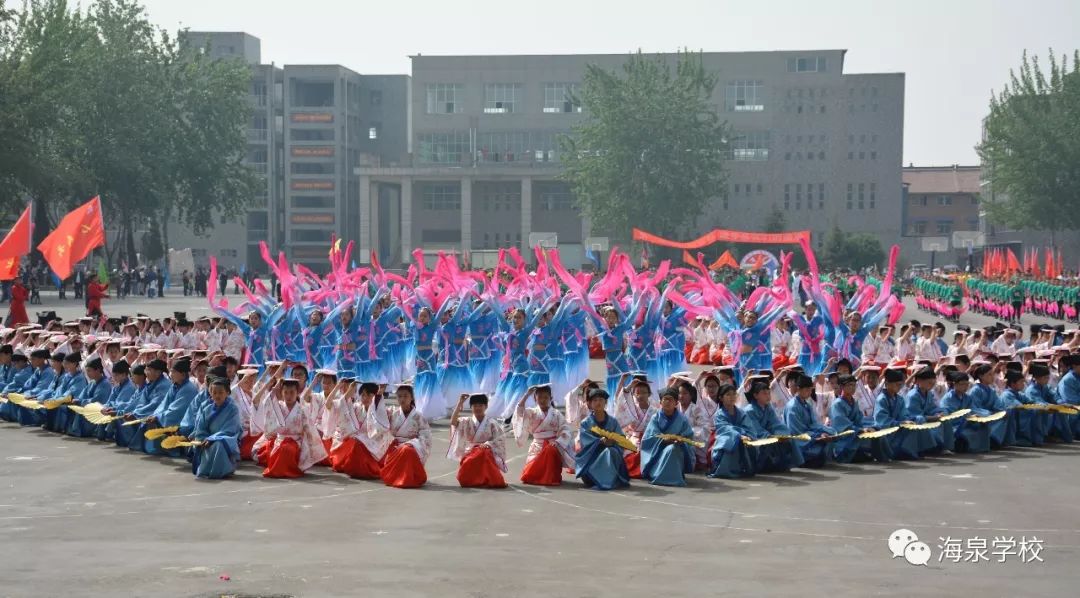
left=189, top=376, right=243, bottom=479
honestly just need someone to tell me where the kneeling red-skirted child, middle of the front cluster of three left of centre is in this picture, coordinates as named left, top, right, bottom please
left=328, top=382, right=390, bottom=479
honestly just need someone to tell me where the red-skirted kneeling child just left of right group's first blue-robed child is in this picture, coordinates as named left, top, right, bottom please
left=511, top=384, right=573, bottom=486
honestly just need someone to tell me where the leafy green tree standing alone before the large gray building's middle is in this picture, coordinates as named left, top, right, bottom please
left=561, top=52, right=728, bottom=241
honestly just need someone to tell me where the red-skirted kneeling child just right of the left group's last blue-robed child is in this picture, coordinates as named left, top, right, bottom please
left=252, top=378, right=326, bottom=477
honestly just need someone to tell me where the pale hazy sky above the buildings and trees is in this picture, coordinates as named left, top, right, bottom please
left=137, top=0, right=1080, bottom=165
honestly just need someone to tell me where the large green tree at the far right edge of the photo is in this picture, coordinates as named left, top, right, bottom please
left=976, top=51, right=1080, bottom=235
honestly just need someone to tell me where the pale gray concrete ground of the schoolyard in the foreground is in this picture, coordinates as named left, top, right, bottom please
left=0, top=291, right=1080, bottom=597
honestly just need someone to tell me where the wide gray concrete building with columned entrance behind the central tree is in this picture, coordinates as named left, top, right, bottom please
left=355, top=50, right=904, bottom=264
